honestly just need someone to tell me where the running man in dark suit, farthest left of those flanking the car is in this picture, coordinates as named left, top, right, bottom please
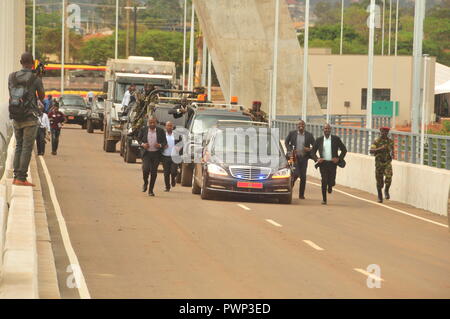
left=137, top=116, right=167, bottom=196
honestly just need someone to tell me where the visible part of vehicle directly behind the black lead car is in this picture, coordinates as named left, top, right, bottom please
left=181, top=104, right=252, bottom=186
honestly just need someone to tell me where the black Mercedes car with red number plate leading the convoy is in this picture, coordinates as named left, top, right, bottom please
left=192, top=121, right=292, bottom=204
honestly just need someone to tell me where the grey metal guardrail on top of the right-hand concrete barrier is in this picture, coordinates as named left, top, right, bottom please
left=272, top=120, right=450, bottom=169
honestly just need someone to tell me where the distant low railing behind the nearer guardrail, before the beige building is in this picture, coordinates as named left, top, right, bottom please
left=276, top=114, right=392, bottom=128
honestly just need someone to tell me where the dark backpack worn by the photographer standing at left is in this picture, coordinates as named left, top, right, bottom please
left=9, top=72, right=36, bottom=122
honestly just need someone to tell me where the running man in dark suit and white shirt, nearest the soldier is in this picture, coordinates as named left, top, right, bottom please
left=311, top=124, right=347, bottom=205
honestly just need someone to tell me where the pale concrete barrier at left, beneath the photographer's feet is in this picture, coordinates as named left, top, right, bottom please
left=0, top=137, right=39, bottom=299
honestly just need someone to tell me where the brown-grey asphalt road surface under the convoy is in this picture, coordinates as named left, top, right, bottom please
left=37, top=126, right=450, bottom=298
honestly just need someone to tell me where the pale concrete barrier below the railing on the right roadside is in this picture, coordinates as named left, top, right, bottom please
left=308, top=153, right=450, bottom=216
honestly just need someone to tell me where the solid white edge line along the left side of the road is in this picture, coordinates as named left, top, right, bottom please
left=39, top=156, right=91, bottom=299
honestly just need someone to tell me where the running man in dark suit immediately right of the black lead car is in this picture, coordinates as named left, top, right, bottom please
left=284, top=120, right=314, bottom=199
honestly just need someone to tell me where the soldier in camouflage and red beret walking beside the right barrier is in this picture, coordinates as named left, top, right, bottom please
left=370, top=127, right=394, bottom=203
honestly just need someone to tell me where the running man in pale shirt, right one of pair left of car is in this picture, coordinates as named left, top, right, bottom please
left=162, top=121, right=180, bottom=192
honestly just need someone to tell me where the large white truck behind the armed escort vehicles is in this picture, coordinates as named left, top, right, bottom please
left=103, top=56, right=176, bottom=152
